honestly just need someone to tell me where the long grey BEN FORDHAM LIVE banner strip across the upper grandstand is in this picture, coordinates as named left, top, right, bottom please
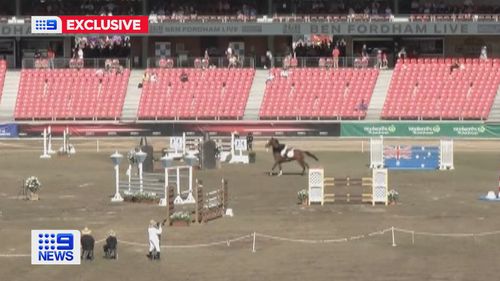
left=0, top=21, right=490, bottom=37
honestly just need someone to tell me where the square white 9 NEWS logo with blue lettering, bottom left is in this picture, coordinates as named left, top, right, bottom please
left=31, top=230, right=80, bottom=265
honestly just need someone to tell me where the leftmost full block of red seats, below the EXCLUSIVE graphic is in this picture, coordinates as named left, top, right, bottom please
left=14, top=69, right=130, bottom=120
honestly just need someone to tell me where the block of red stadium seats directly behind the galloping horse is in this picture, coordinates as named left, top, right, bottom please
left=259, top=68, right=378, bottom=119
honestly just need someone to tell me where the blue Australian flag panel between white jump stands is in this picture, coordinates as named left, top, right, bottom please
left=384, top=145, right=439, bottom=170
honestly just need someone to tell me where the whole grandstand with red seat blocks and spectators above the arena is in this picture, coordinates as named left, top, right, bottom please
left=0, top=0, right=500, bottom=127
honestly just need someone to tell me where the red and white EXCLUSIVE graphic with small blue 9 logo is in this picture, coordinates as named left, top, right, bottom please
left=31, top=16, right=149, bottom=34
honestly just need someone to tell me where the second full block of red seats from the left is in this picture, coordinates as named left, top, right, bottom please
left=138, top=69, right=255, bottom=120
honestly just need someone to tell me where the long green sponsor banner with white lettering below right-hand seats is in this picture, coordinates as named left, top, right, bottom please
left=340, top=122, right=500, bottom=138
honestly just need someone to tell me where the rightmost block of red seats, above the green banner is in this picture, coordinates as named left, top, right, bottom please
left=381, top=59, right=500, bottom=120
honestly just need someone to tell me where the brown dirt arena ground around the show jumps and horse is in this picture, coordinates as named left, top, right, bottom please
left=0, top=139, right=500, bottom=281
